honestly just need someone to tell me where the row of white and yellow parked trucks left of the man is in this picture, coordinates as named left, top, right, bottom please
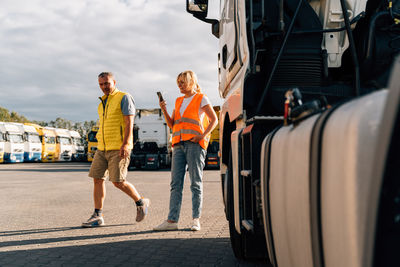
left=0, top=122, right=85, bottom=163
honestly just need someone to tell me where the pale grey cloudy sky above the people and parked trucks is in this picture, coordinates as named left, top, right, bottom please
left=0, top=0, right=222, bottom=122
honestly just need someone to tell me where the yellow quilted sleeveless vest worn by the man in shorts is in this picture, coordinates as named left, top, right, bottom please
left=96, top=89, right=133, bottom=151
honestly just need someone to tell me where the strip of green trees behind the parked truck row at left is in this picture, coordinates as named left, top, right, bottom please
left=0, top=107, right=96, bottom=137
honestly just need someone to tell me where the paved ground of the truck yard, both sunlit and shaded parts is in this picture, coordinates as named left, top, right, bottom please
left=0, top=162, right=270, bottom=266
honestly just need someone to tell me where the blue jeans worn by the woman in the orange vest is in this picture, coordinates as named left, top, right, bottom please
left=168, top=141, right=207, bottom=222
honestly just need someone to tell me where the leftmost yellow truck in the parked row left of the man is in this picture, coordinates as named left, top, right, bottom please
left=26, top=123, right=56, bottom=162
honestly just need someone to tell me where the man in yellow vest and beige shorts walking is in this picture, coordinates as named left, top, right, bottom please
left=82, top=72, right=150, bottom=227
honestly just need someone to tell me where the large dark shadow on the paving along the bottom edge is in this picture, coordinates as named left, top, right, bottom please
left=0, top=238, right=267, bottom=266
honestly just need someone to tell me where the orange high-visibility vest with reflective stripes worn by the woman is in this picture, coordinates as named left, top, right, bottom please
left=172, top=94, right=210, bottom=150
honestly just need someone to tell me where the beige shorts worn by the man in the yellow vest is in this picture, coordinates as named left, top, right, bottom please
left=89, top=150, right=131, bottom=182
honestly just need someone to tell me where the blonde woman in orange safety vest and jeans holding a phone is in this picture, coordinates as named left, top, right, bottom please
left=154, top=70, right=218, bottom=231
